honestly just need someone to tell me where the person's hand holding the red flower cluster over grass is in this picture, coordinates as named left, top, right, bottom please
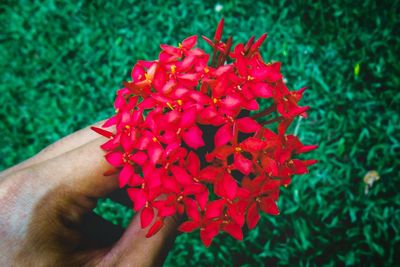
left=0, top=122, right=177, bottom=266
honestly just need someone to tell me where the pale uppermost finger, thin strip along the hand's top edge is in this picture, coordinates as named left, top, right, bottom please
left=0, top=121, right=108, bottom=179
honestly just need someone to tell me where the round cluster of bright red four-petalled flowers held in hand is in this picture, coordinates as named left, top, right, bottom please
left=93, top=20, right=316, bottom=246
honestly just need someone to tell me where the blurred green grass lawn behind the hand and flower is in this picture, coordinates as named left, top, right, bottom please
left=0, top=0, right=400, bottom=266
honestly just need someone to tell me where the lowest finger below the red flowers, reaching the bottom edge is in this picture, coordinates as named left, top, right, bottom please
left=102, top=214, right=178, bottom=266
